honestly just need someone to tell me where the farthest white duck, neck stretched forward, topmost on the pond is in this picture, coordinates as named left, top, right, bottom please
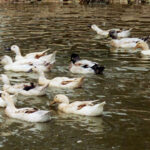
left=91, top=24, right=132, bottom=38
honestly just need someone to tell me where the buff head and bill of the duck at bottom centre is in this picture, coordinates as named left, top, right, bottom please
left=50, top=94, right=69, bottom=106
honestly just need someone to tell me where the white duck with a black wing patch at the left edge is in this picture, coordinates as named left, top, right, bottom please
left=0, top=74, right=48, bottom=96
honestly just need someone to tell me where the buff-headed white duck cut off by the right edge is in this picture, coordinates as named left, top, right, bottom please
left=135, top=41, right=150, bottom=57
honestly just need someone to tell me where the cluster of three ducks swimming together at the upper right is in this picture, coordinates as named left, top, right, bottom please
left=91, top=24, right=150, bottom=58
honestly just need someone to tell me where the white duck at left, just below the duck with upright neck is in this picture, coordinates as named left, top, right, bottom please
left=1, top=56, right=53, bottom=72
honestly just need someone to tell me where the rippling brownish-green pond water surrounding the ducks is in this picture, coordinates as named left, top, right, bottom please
left=0, top=3, right=150, bottom=150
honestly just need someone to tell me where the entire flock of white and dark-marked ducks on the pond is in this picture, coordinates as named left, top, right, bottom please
left=0, top=25, right=150, bottom=122
